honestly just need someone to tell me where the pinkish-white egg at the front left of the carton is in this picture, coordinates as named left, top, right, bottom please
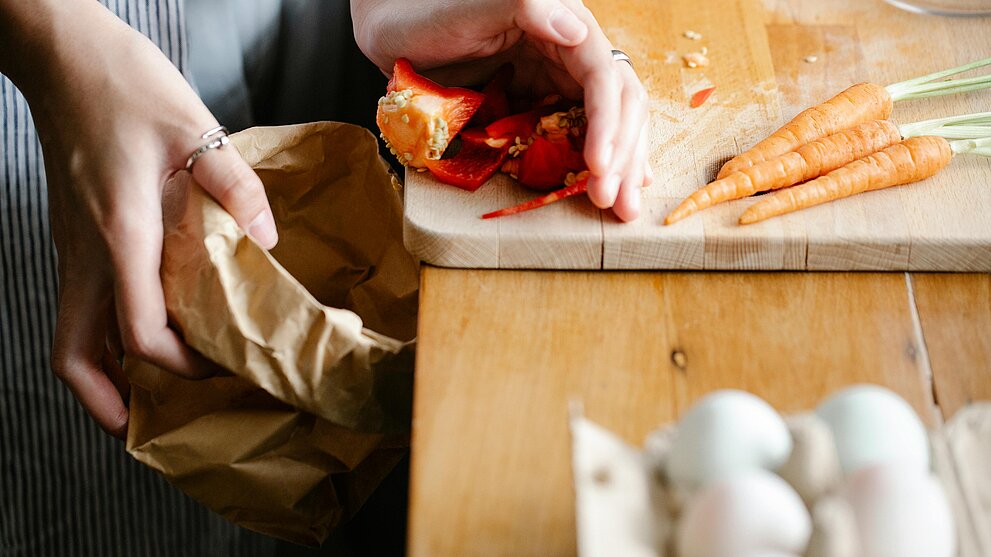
left=677, top=470, right=812, bottom=557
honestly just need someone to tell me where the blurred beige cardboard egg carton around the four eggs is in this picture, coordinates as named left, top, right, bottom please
left=571, top=403, right=991, bottom=557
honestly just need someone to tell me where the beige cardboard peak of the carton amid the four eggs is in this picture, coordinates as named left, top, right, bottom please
left=778, top=413, right=842, bottom=508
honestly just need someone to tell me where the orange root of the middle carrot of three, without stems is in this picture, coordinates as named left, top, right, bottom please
left=664, top=120, right=902, bottom=224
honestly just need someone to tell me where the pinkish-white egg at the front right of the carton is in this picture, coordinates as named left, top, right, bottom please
left=842, top=463, right=956, bottom=557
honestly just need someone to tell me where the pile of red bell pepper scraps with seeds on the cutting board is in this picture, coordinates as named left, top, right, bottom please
left=376, top=59, right=588, bottom=218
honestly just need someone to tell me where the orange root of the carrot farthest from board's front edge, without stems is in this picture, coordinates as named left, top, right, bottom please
left=716, top=83, right=893, bottom=179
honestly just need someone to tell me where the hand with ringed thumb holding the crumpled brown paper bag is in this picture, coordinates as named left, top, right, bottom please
left=0, top=0, right=277, bottom=437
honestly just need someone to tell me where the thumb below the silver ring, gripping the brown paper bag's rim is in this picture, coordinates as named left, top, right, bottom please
left=193, top=142, right=279, bottom=249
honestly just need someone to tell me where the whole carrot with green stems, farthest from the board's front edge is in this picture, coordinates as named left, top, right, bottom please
left=716, top=58, right=991, bottom=179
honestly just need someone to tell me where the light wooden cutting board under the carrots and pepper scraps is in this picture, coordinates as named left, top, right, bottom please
left=405, top=0, right=991, bottom=271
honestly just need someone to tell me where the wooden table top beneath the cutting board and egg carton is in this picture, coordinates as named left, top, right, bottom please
left=408, top=0, right=991, bottom=557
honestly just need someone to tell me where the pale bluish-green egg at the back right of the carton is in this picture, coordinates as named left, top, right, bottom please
left=816, top=385, right=929, bottom=474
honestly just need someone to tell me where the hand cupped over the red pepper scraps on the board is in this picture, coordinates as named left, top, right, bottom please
left=351, top=0, right=653, bottom=221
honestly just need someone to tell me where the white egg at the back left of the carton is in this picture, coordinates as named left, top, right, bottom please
left=667, top=390, right=792, bottom=493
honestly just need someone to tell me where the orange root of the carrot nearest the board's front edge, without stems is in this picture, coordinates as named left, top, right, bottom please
left=740, top=136, right=953, bottom=224
